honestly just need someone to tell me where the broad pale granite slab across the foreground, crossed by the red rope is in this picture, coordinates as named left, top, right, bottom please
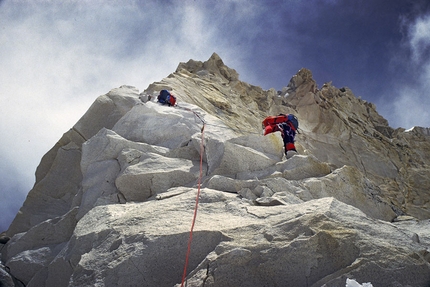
left=7, top=191, right=430, bottom=286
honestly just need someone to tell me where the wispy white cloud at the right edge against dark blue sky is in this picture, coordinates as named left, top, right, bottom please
left=378, top=14, right=430, bottom=129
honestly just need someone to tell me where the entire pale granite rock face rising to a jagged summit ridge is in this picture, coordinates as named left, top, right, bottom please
left=0, top=54, right=430, bottom=286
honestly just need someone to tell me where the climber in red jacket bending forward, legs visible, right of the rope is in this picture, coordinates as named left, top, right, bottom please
left=263, top=114, right=299, bottom=159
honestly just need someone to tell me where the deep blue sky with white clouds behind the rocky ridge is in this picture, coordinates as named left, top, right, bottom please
left=0, top=0, right=430, bottom=232
